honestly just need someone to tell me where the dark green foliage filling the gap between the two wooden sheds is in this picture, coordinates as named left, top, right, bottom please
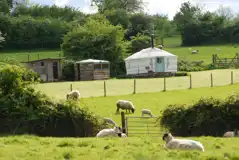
left=62, top=60, right=75, bottom=81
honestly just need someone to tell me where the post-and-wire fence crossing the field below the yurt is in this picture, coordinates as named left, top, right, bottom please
left=62, top=70, right=239, bottom=97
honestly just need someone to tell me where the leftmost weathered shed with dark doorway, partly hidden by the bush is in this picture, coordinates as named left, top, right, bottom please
left=22, top=58, right=62, bottom=82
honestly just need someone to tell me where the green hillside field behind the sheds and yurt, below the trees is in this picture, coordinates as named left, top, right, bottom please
left=0, top=36, right=238, bottom=64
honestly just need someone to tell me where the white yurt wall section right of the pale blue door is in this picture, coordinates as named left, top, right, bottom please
left=164, top=56, right=178, bottom=73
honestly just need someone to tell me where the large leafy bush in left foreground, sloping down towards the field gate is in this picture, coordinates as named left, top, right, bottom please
left=0, top=64, right=104, bottom=137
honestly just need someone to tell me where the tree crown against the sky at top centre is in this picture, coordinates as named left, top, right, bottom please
left=92, top=0, right=144, bottom=13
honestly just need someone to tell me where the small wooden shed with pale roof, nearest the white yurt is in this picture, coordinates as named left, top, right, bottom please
left=75, top=59, right=110, bottom=81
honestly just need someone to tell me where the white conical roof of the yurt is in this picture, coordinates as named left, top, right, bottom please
left=124, top=47, right=175, bottom=61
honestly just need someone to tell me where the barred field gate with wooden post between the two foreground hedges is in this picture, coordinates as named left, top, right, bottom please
left=121, top=112, right=162, bottom=137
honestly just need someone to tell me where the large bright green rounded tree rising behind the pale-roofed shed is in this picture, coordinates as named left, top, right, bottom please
left=61, top=15, right=123, bottom=62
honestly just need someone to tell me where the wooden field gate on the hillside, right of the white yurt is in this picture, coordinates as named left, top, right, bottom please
left=212, top=53, right=239, bottom=67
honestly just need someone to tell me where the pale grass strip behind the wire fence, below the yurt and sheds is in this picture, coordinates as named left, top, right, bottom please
left=36, top=69, right=239, bottom=99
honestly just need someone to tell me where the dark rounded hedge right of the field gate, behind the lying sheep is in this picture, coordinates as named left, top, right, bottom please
left=160, top=94, right=239, bottom=136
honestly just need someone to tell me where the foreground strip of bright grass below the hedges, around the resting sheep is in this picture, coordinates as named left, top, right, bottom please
left=0, top=136, right=239, bottom=160
